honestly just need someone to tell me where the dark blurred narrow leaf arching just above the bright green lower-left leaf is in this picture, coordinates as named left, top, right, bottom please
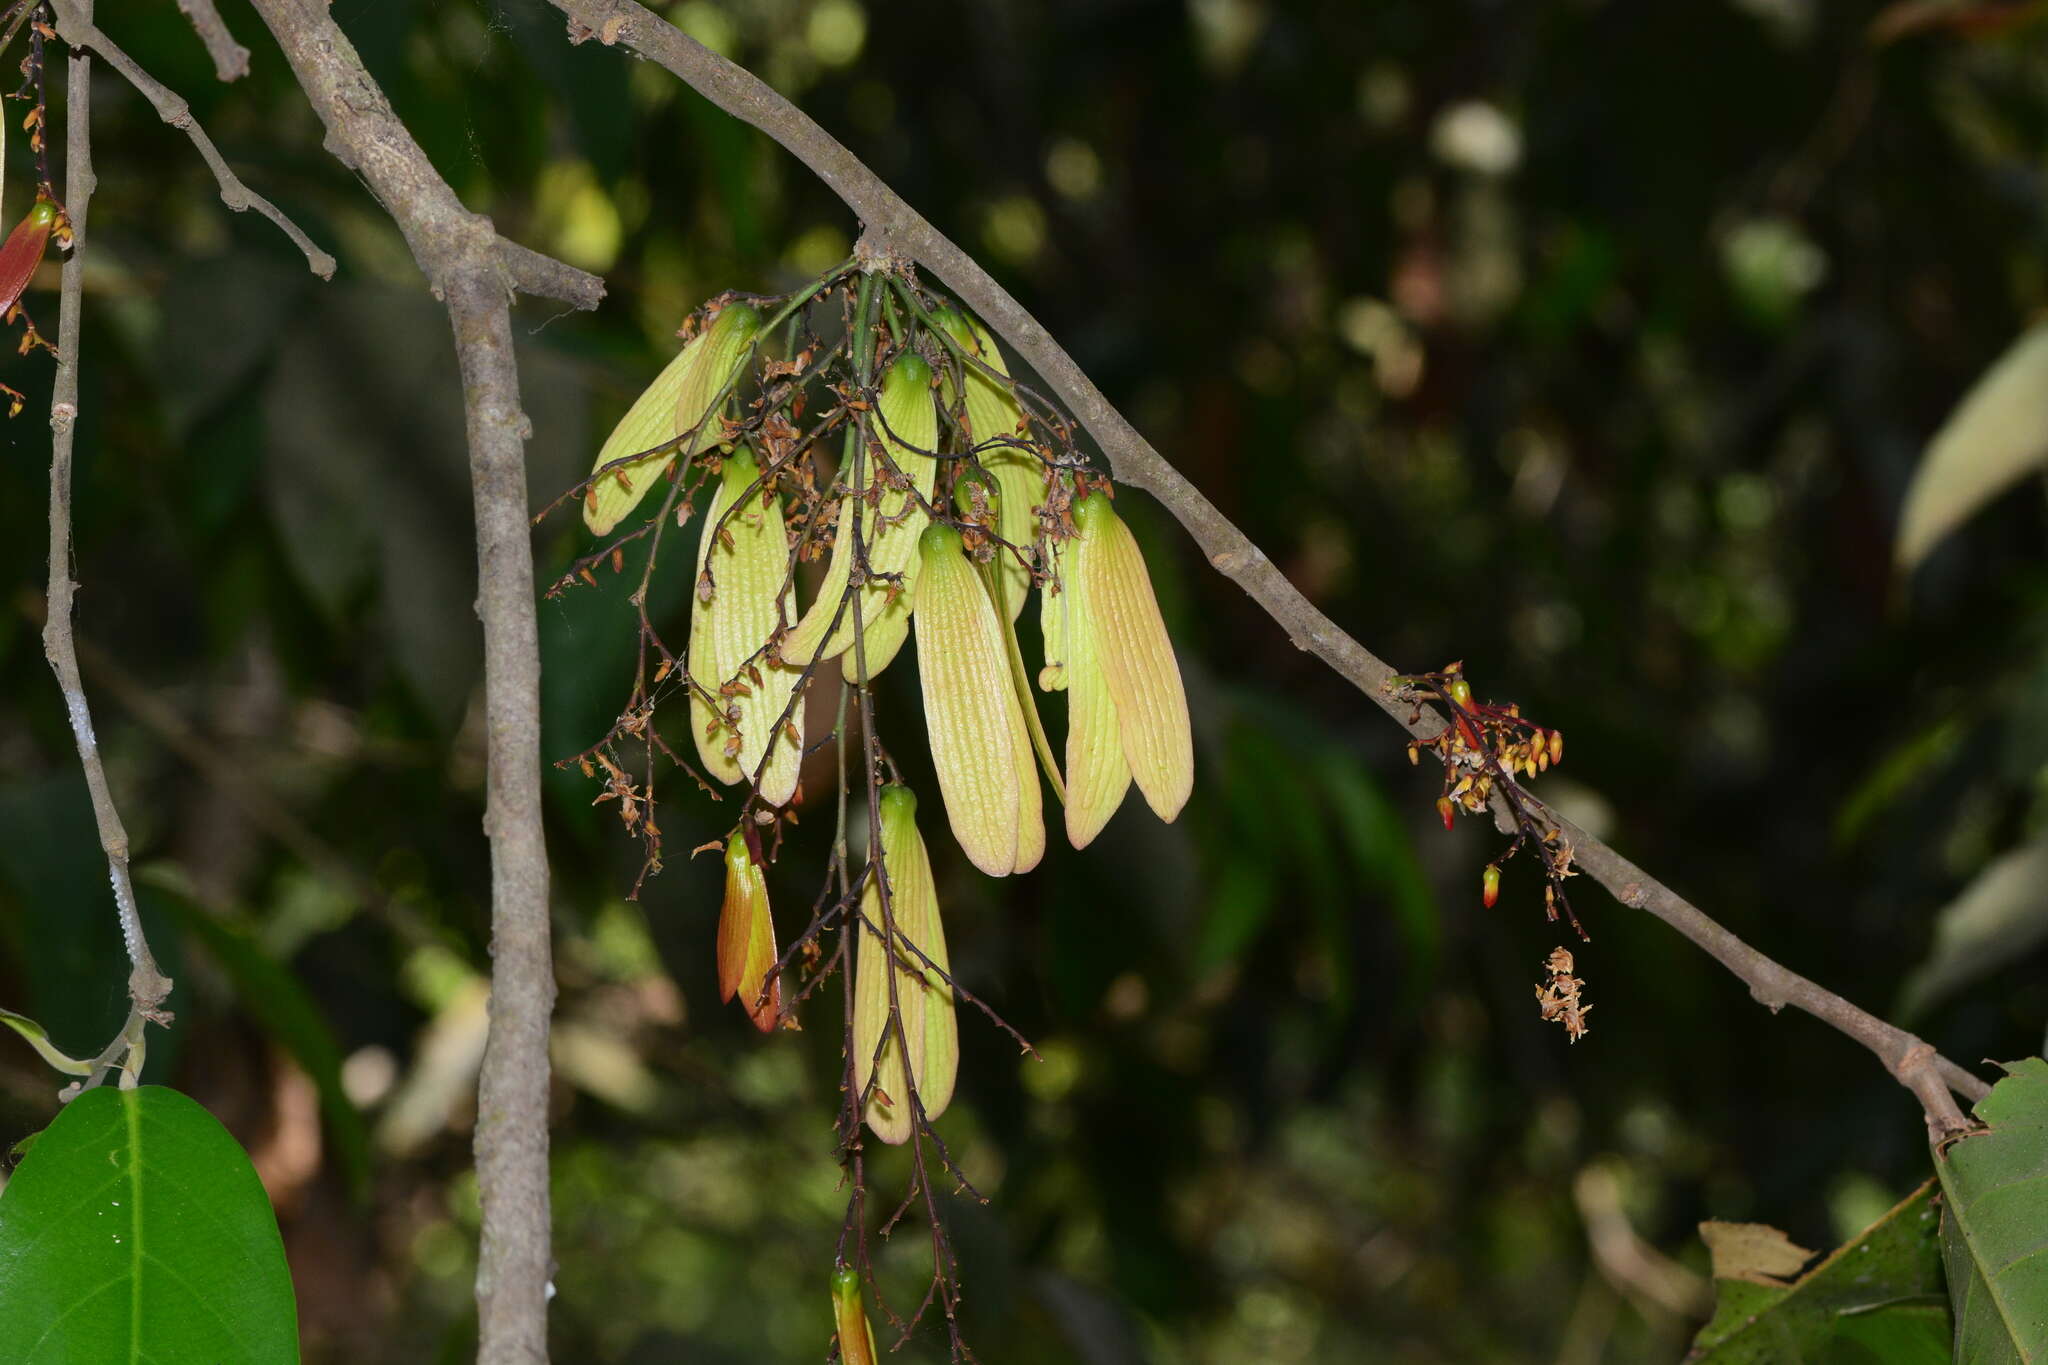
left=139, top=886, right=371, bottom=1195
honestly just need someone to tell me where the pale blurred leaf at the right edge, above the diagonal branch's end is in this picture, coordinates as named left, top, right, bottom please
left=1896, top=325, right=2048, bottom=573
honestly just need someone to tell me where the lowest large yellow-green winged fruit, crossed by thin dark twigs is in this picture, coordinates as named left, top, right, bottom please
left=854, top=786, right=961, bottom=1142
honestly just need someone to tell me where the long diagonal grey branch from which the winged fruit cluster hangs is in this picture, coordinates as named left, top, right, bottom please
left=549, top=0, right=1989, bottom=1128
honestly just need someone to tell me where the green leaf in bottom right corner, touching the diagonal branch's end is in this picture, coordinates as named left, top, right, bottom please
left=1935, top=1056, right=2048, bottom=1365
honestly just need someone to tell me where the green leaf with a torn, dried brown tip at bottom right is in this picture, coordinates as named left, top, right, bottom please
left=1686, top=1181, right=1948, bottom=1365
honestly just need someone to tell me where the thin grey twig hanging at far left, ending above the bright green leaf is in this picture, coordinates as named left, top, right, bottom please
left=43, top=0, right=170, bottom=1087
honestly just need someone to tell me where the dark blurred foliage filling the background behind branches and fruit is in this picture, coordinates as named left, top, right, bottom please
left=0, top=0, right=2048, bottom=1365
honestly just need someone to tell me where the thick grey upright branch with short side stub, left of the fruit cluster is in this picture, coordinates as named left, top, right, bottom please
left=238, top=0, right=561, bottom=1365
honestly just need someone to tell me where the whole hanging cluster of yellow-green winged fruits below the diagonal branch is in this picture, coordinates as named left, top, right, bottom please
left=584, top=272, right=1194, bottom=1142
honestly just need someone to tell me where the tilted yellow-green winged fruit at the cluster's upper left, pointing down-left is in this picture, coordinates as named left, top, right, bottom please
left=584, top=303, right=762, bottom=536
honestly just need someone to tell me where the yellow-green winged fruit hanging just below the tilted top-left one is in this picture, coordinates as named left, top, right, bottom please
left=690, top=446, right=803, bottom=806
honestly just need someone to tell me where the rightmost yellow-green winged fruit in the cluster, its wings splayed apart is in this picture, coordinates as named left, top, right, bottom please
left=1063, top=491, right=1194, bottom=847
